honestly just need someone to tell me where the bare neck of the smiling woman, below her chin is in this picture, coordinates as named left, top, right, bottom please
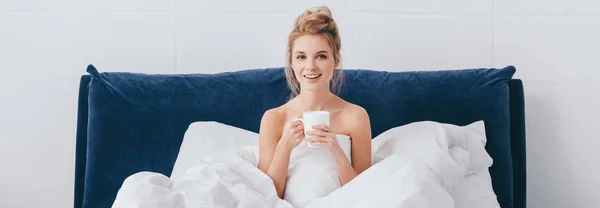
left=296, top=90, right=335, bottom=111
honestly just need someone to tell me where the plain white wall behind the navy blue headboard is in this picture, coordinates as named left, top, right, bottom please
left=0, top=0, right=600, bottom=208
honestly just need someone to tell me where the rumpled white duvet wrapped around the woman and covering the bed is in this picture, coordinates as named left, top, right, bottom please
left=113, top=122, right=491, bottom=208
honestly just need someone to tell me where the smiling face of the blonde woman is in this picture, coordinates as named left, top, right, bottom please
left=290, top=35, right=336, bottom=91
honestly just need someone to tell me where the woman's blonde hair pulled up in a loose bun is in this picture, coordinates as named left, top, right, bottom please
left=285, top=6, right=343, bottom=99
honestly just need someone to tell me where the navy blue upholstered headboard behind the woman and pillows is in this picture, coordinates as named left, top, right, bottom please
left=74, top=65, right=526, bottom=208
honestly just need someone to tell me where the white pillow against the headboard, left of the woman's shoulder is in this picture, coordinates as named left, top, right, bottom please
left=171, top=121, right=258, bottom=180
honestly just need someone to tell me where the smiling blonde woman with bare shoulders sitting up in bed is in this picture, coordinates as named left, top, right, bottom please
left=258, top=7, right=371, bottom=202
